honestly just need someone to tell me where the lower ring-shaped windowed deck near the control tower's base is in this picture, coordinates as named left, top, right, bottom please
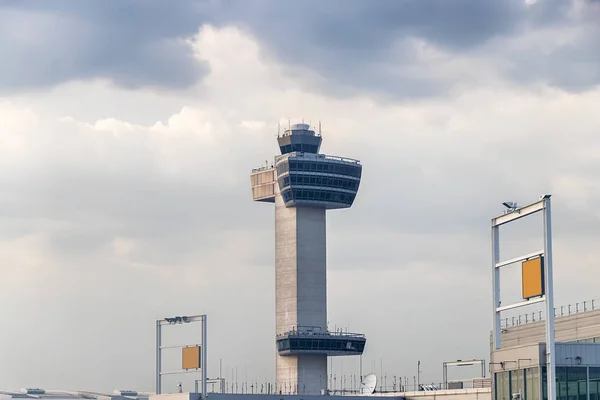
left=277, top=327, right=367, bottom=356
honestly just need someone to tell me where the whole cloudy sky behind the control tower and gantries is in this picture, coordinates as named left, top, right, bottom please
left=0, top=0, right=600, bottom=390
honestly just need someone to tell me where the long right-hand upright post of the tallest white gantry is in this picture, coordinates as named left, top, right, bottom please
left=543, top=196, right=556, bottom=400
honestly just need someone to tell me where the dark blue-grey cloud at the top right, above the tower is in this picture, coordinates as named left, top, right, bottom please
left=225, top=0, right=598, bottom=99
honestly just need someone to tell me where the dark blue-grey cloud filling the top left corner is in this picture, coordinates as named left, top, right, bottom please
left=0, top=0, right=213, bottom=92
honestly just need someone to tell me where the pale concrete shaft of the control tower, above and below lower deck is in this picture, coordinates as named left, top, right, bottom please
left=275, top=193, right=327, bottom=394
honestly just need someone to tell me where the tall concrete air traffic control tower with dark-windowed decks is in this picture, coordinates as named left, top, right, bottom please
left=251, top=123, right=366, bottom=394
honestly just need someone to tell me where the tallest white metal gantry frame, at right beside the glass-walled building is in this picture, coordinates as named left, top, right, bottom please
left=492, top=194, right=556, bottom=400
